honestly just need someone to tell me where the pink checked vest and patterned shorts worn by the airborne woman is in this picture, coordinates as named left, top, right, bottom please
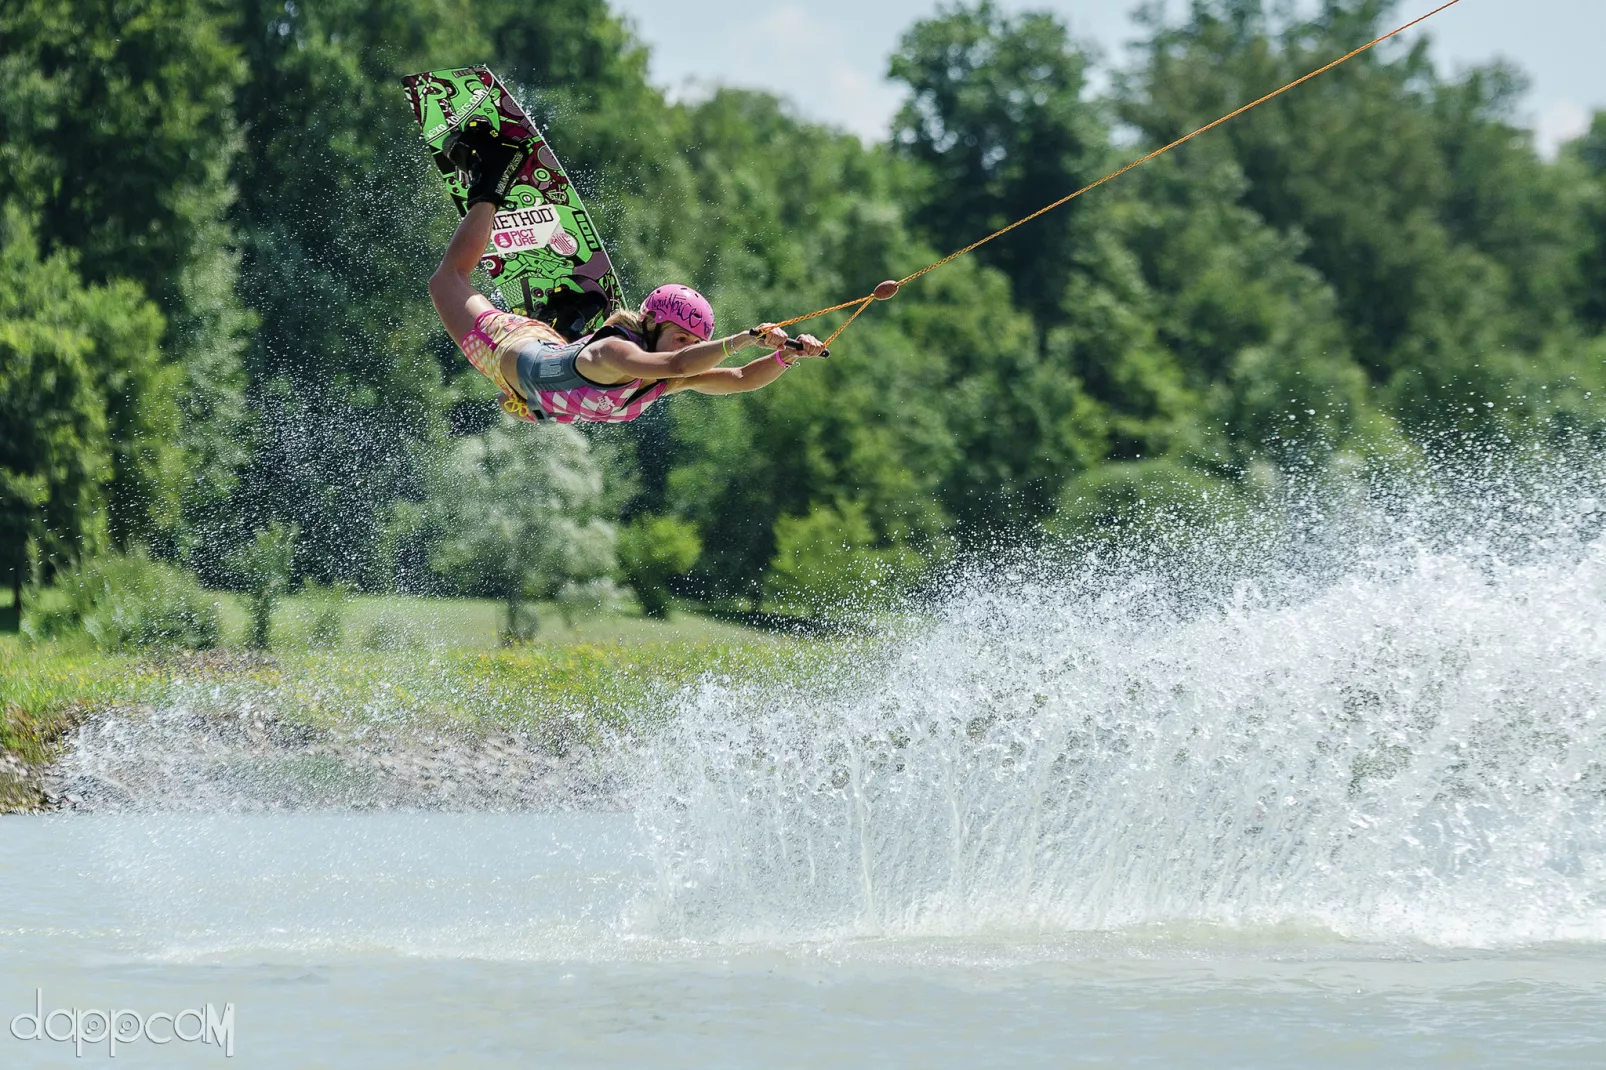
left=458, top=308, right=668, bottom=424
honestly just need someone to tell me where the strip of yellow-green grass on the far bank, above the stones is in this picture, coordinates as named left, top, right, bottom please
left=0, top=596, right=830, bottom=784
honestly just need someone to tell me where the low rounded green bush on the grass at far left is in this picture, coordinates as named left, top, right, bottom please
left=22, top=551, right=220, bottom=651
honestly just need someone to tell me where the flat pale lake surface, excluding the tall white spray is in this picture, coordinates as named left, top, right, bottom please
left=0, top=813, right=1606, bottom=1068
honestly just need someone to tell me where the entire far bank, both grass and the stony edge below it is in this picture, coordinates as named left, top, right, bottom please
left=0, top=630, right=835, bottom=813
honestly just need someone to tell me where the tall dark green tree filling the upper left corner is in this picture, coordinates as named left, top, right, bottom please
left=0, top=0, right=249, bottom=549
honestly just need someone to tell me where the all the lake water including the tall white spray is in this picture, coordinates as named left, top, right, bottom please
left=0, top=468, right=1606, bottom=1070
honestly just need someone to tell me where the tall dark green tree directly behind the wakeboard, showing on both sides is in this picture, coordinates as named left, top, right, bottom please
left=218, top=0, right=666, bottom=588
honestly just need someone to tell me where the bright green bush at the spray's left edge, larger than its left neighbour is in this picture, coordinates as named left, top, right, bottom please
left=764, top=503, right=922, bottom=619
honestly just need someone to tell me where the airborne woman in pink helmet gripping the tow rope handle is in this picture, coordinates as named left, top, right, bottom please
left=429, top=129, right=825, bottom=423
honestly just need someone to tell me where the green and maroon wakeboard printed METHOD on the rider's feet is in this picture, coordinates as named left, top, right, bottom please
left=402, top=66, right=625, bottom=337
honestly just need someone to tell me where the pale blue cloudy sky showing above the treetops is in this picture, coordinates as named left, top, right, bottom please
left=609, top=0, right=1606, bottom=154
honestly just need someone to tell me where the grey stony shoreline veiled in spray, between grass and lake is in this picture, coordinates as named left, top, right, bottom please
left=0, top=705, right=618, bottom=815
